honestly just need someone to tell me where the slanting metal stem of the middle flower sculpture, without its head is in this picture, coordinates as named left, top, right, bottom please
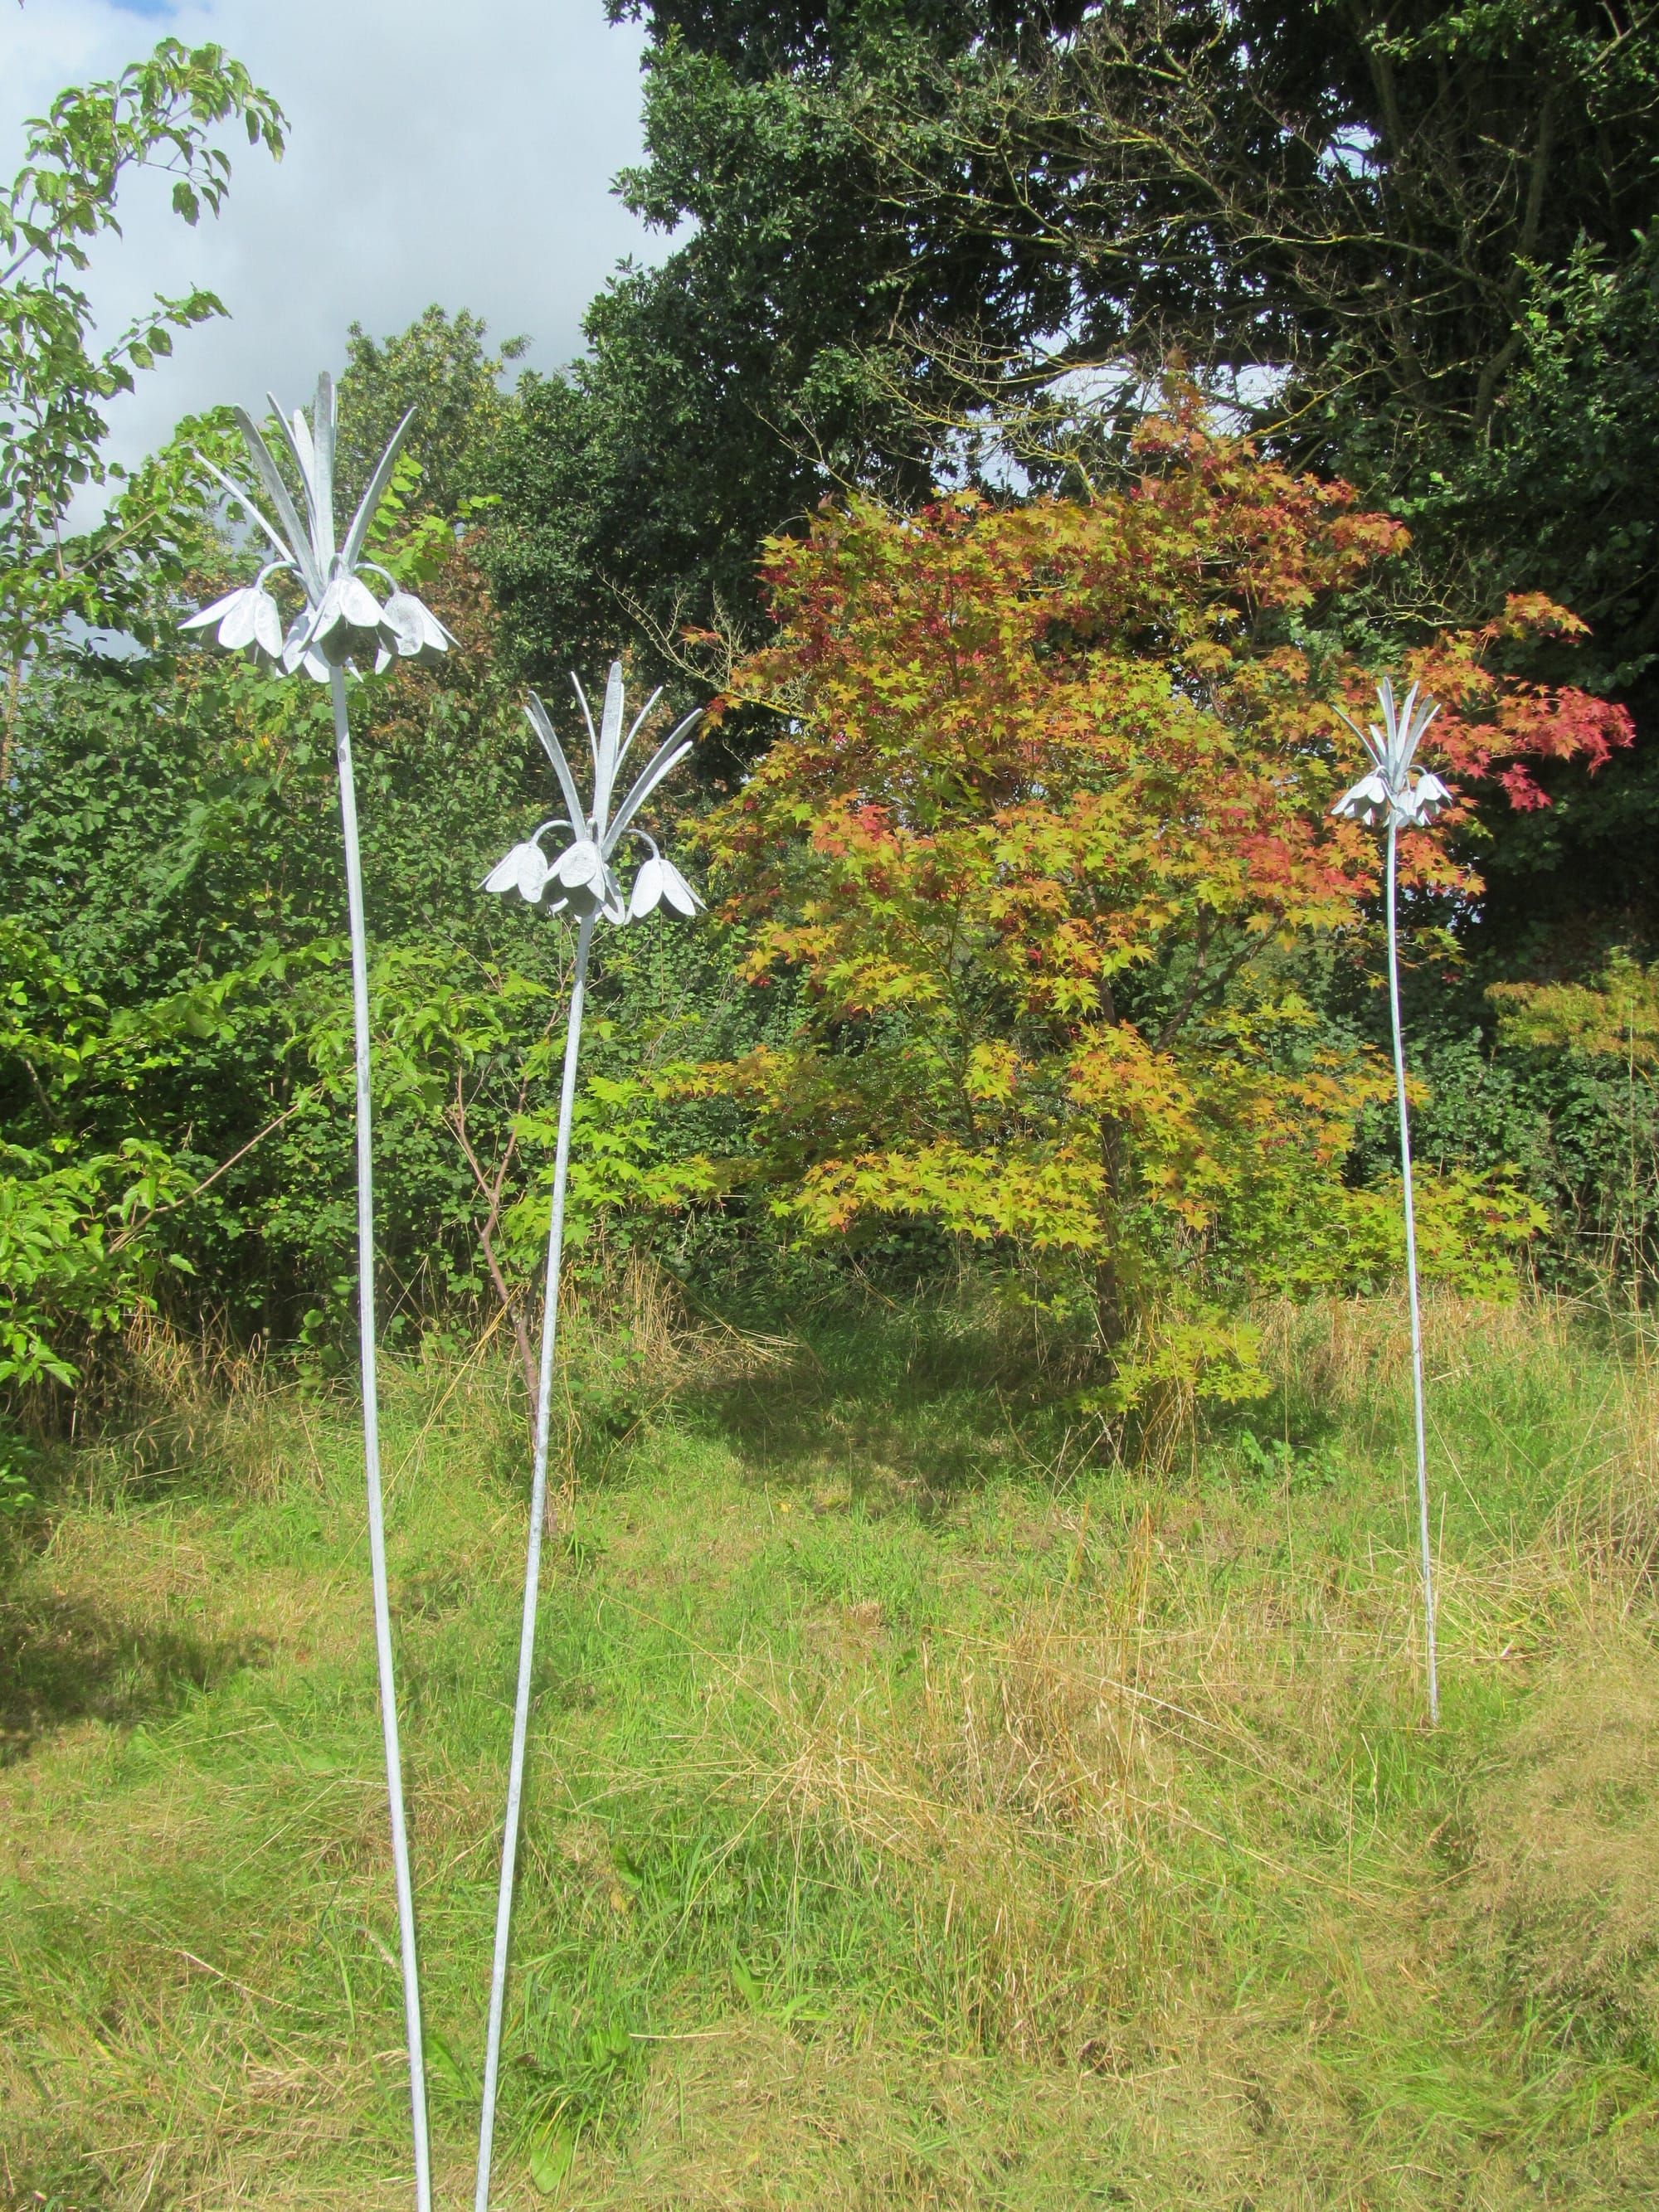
left=474, top=916, right=593, bottom=2212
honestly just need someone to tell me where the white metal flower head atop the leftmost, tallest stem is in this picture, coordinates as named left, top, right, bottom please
left=183, top=376, right=454, bottom=683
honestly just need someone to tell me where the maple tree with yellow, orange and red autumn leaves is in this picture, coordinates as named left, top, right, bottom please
left=706, top=407, right=1628, bottom=1400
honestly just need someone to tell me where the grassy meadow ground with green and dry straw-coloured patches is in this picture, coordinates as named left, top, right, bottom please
left=0, top=1300, right=1659, bottom=2212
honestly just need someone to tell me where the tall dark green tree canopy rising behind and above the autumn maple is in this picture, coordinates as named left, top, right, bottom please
left=548, top=0, right=1659, bottom=920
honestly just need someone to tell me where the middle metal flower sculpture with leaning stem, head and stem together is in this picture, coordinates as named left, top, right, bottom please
left=475, top=661, right=701, bottom=2212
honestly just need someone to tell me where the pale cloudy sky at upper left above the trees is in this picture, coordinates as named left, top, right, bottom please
left=0, top=0, right=666, bottom=522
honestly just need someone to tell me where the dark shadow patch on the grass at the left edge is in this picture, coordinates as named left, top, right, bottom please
left=0, top=1592, right=265, bottom=1765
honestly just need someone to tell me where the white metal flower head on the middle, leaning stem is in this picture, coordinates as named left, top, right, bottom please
left=480, top=661, right=701, bottom=929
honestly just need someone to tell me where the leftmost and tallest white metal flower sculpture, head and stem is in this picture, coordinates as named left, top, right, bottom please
left=183, top=376, right=454, bottom=2212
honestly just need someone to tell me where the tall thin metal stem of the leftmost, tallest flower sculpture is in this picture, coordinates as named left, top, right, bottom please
left=329, top=668, right=431, bottom=2212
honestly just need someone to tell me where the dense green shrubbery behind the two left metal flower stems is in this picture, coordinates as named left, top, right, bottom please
left=0, top=526, right=814, bottom=1359
